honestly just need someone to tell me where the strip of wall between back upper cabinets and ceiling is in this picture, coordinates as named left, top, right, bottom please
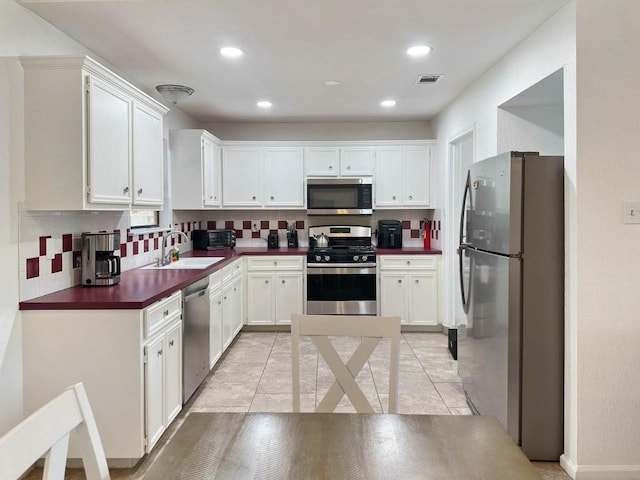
left=204, top=122, right=434, bottom=141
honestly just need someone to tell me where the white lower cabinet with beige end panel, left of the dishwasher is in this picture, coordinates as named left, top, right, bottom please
left=22, top=291, right=182, bottom=468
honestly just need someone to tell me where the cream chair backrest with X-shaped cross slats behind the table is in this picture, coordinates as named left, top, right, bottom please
left=291, top=313, right=400, bottom=413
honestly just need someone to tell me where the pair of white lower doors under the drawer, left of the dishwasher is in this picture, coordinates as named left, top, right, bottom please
left=145, top=316, right=182, bottom=453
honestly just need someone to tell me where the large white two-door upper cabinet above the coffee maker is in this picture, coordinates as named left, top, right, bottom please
left=20, top=57, right=168, bottom=210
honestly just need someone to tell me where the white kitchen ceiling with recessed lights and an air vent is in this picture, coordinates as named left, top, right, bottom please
left=20, top=0, right=568, bottom=123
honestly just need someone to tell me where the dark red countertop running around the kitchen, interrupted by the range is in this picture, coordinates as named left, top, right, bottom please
left=20, top=247, right=441, bottom=310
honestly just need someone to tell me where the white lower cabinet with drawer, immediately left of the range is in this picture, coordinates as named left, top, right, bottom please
left=247, top=256, right=304, bottom=325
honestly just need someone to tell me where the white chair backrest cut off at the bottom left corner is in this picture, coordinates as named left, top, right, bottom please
left=0, top=383, right=110, bottom=480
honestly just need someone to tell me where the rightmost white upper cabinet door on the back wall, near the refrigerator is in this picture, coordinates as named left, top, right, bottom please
left=402, top=146, right=431, bottom=207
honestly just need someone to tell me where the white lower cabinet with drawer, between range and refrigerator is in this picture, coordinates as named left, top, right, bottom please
left=379, top=255, right=441, bottom=325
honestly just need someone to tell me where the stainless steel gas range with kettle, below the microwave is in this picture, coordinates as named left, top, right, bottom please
left=307, top=225, right=378, bottom=315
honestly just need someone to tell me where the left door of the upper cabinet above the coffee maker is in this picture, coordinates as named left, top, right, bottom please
left=87, top=77, right=132, bottom=204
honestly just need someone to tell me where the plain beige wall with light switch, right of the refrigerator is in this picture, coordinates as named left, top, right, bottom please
left=569, top=0, right=640, bottom=479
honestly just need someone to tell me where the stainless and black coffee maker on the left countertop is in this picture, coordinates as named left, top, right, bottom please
left=82, top=232, right=120, bottom=287
